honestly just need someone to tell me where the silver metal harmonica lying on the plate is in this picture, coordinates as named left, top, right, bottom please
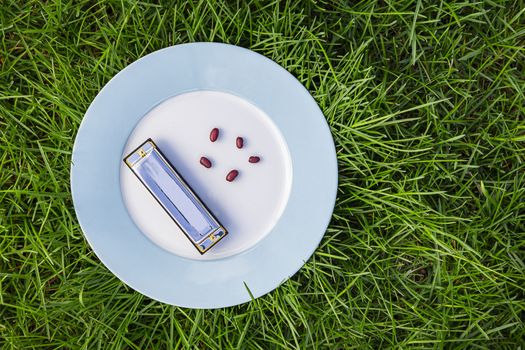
left=124, top=139, right=228, bottom=254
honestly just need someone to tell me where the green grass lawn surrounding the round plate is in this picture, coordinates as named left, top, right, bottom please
left=0, top=0, right=525, bottom=349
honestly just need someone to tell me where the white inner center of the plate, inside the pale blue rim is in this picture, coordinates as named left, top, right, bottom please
left=120, top=91, right=292, bottom=260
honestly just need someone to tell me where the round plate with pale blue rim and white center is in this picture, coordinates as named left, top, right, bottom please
left=71, top=43, right=337, bottom=308
